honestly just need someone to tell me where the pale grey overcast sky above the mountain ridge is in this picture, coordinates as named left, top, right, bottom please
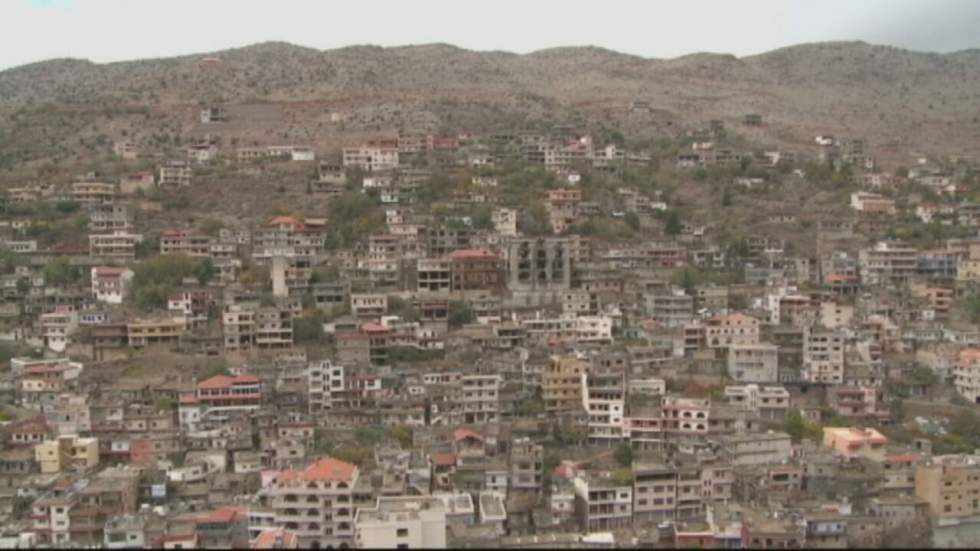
left=0, top=0, right=980, bottom=69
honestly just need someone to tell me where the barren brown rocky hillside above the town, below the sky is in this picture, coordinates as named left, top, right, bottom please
left=0, top=42, right=980, bottom=166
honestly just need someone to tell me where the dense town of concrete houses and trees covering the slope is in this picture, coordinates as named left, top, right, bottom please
left=0, top=99, right=980, bottom=549
